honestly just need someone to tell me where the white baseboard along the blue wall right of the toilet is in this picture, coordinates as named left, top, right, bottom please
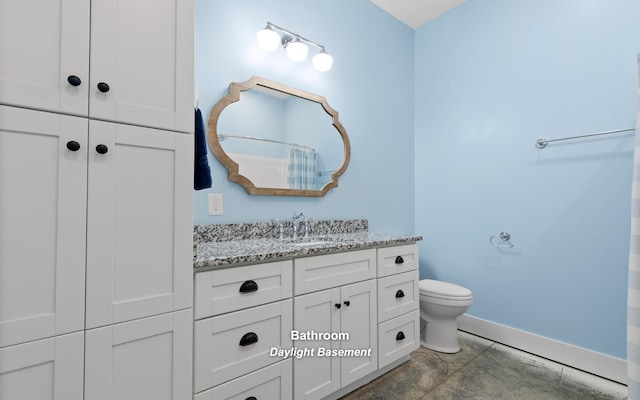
left=458, top=314, right=627, bottom=385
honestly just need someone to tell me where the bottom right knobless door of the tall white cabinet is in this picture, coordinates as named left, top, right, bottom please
left=85, top=310, right=193, bottom=400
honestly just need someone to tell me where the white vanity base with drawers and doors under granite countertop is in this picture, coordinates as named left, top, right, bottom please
left=194, top=244, right=420, bottom=400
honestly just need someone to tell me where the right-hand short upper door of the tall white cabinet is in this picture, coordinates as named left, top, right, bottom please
left=89, top=0, right=194, bottom=132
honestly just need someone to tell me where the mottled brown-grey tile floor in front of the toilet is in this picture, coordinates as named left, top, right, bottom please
left=342, top=332, right=627, bottom=400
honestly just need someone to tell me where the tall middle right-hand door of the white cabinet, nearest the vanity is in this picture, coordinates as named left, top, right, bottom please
left=87, top=120, right=193, bottom=328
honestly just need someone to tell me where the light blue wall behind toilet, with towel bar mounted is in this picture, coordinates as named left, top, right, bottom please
left=415, top=0, right=640, bottom=358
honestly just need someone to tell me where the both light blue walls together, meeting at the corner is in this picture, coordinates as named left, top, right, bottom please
left=195, top=0, right=640, bottom=358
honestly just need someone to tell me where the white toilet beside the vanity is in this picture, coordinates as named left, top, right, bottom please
left=419, top=279, right=473, bottom=353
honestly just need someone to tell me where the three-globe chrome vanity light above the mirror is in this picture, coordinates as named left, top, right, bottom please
left=256, top=22, right=333, bottom=72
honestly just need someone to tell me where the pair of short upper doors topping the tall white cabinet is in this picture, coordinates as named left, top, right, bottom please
left=0, top=0, right=194, bottom=132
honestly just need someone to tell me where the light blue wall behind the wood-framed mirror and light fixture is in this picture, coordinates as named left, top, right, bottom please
left=195, top=0, right=415, bottom=233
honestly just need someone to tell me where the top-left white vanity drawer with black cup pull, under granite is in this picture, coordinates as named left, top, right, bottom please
left=194, top=260, right=293, bottom=319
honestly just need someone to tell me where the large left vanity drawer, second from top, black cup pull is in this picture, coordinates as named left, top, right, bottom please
left=194, top=299, right=293, bottom=393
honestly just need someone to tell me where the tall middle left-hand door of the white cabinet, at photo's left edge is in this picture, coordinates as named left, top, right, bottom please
left=0, top=106, right=87, bottom=347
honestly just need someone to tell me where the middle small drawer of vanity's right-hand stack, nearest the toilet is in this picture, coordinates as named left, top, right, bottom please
left=378, top=270, right=420, bottom=322
